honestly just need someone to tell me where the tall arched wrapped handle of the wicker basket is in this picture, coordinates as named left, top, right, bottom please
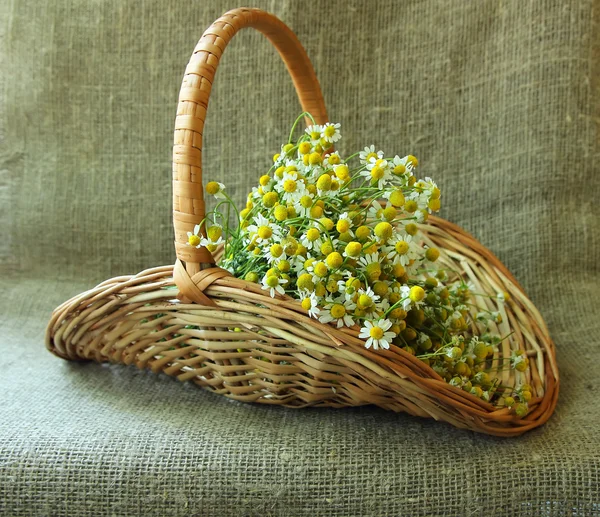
left=173, top=8, right=327, bottom=303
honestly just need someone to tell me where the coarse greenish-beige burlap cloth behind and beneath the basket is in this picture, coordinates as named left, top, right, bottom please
left=0, top=0, right=600, bottom=517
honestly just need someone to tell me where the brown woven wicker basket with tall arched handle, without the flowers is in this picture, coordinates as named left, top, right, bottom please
left=46, top=9, right=559, bottom=436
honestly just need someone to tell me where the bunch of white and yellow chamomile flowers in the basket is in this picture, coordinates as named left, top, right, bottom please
left=188, top=113, right=531, bottom=416
